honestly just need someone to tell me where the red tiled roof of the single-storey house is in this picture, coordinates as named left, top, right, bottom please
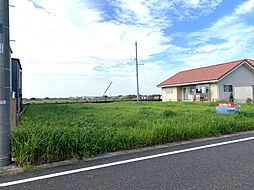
left=157, top=59, right=254, bottom=87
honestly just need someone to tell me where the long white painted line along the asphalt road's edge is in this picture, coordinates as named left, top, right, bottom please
left=0, top=137, right=254, bottom=187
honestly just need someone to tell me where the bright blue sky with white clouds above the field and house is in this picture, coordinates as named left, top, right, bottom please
left=10, top=0, right=254, bottom=98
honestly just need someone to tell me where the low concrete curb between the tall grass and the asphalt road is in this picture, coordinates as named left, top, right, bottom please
left=0, top=130, right=254, bottom=176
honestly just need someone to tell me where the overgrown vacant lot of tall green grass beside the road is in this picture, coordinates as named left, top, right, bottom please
left=12, top=102, right=254, bottom=165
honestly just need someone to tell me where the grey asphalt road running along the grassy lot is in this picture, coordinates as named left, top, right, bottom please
left=0, top=133, right=254, bottom=190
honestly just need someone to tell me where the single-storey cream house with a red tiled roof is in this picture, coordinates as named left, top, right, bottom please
left=157, top=59, right=254, bottom=103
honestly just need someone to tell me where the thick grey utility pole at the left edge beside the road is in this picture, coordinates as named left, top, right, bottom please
left=0, top=0, right=11, bottom=166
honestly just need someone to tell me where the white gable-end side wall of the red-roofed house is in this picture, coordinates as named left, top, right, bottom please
left=218, top=65, right=254, bottom=99
